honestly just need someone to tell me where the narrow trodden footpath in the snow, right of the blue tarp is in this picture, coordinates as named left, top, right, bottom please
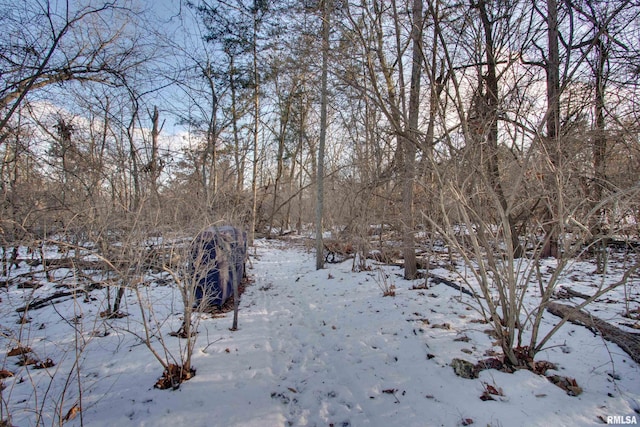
left=242, top=242, right=389, bottom=426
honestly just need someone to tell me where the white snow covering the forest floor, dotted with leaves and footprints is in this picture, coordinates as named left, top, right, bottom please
left=0, top=240, right=640, bottom=427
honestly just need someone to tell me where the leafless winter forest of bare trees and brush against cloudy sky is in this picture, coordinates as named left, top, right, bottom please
left=0, top=0, right=640, bottom=424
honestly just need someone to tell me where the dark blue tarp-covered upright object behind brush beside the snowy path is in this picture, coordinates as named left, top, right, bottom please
left=191, top=225, right=247, bottom=307
